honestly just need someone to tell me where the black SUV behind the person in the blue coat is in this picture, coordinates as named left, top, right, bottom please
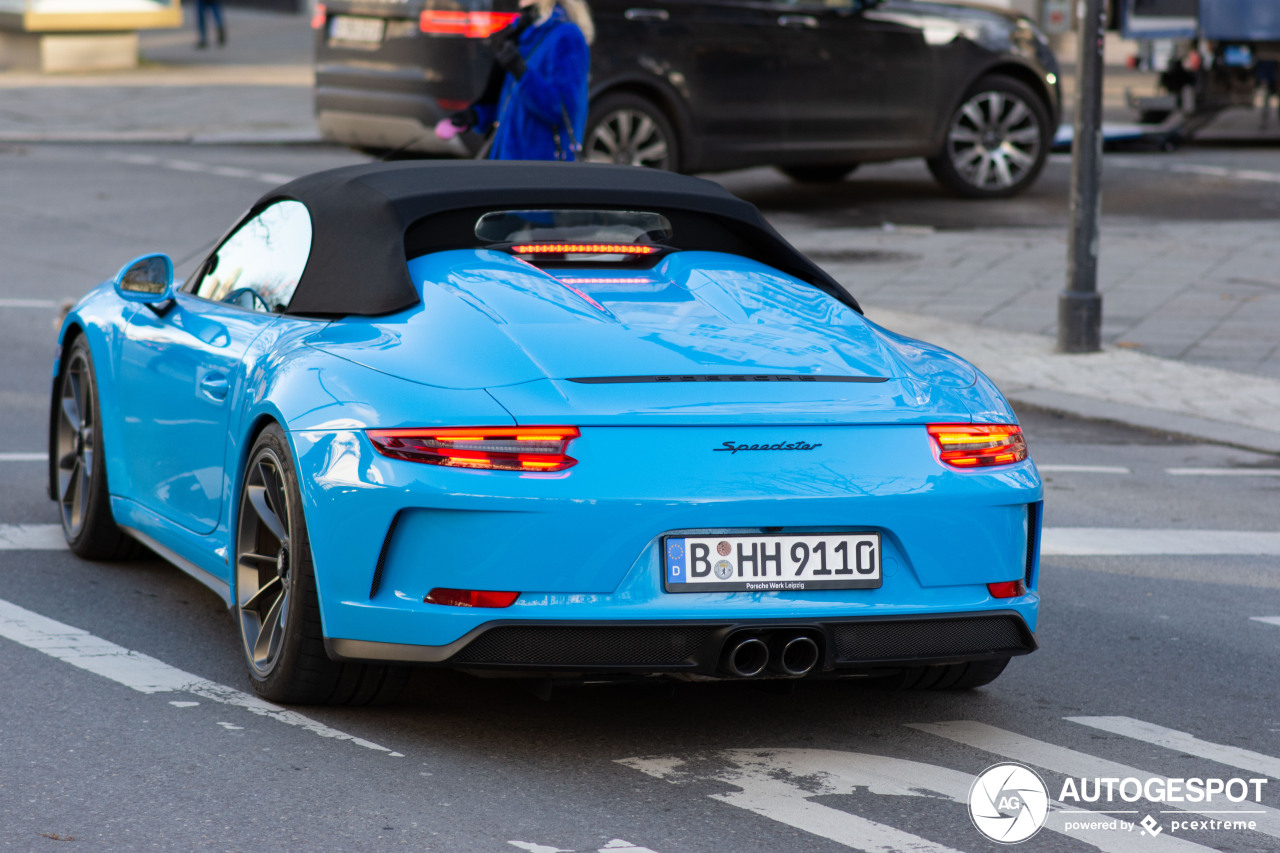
left=312, top=0, right=1061, bottom=197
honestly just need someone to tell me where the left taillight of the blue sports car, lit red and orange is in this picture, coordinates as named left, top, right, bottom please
left=365, top=427, right=581, bottom=471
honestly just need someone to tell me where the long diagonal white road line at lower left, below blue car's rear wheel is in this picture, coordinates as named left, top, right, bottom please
left=0, top=599, right=403, bottom=758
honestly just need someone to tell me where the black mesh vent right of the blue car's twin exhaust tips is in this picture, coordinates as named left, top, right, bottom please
left=832, top=616, right=1033, bottom=662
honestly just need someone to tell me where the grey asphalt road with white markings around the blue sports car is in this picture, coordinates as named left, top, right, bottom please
left=0, top=147, right=1280, bottom=853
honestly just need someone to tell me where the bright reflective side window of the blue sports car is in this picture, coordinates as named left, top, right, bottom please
left=192, top=201, right=311, bottom=311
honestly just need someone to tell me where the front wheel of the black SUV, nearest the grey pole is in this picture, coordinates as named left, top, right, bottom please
left=927, top=74, right=1053, bottom=199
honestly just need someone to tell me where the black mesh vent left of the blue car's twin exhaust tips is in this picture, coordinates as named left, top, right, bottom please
left=452, top=625, right=717, bottom=666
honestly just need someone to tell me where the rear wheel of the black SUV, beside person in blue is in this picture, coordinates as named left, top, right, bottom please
left=582, top=92, right=680, bottom=172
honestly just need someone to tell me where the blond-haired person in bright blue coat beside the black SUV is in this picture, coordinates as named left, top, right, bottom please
left=435, top=0, right=595, bottom=160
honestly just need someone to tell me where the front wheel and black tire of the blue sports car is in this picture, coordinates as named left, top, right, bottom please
left=49, top=337, right=145, bottom=560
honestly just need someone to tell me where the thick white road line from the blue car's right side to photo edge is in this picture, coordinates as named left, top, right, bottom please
left=1041, top=528, right=1280, bottom=557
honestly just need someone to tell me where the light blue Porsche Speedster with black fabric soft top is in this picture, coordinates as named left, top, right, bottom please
left=49, top=163, right=1042, bottom=703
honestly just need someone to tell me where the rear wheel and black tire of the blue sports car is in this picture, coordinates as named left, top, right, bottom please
left=236, top=424, right=407, bottom=704
